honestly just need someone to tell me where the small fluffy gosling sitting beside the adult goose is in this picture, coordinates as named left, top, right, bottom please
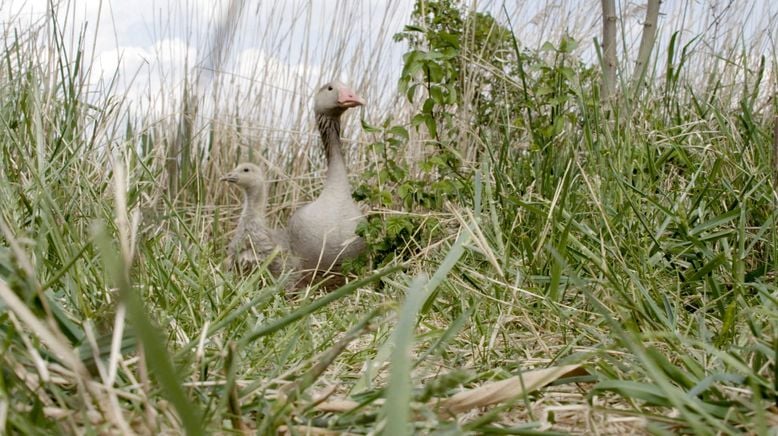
left=221, top=163, right=297, bottom=275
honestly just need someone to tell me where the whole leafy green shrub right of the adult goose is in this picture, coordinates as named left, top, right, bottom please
left=349, top=0, right=596, bottom=278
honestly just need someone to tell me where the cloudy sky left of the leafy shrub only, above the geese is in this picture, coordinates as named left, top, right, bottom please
left=0, top=0, right=410, bottom=115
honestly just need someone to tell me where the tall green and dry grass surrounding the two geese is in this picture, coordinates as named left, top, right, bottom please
left=0, top=2, right=778, bottom=434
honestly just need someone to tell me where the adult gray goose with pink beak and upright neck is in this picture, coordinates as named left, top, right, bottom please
left=289, top=81, right=365, bottom=271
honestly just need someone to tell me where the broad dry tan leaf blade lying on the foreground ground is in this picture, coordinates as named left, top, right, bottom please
left=441, top=364, right=585, bottom=416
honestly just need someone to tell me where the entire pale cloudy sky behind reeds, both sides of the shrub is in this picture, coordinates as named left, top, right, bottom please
left=0, top=0, right=778, bottom=119
